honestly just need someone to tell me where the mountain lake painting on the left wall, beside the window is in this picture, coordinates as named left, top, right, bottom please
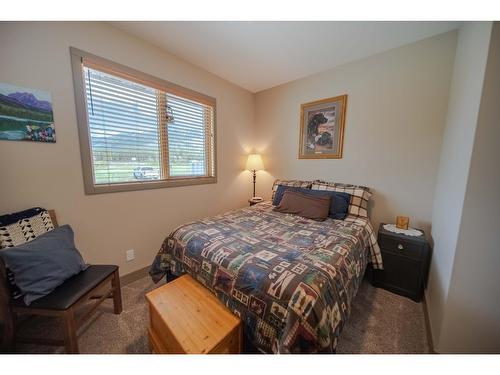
left=0, top=82, right=56, bottom=143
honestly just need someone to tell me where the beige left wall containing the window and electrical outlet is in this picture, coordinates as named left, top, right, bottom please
left=0, top=22, right=254, bottom=274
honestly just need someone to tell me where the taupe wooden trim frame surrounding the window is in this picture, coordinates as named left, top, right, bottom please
left=70, top=47, right=217, bottom=194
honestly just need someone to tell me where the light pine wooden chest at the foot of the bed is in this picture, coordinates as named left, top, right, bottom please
left=146, top=275, right=242, bottom=354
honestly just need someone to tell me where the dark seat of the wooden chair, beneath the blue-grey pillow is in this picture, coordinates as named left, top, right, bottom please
left=13, top=265, right=118, bottom=310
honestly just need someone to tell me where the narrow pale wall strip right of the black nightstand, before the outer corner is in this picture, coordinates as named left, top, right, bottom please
left=426, top=22, right=491, bottom=351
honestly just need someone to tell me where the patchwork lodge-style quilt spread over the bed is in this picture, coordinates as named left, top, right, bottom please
left=150, top=202, right=382, bottom=353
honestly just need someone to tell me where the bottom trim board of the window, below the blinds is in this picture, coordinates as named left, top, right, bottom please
left=85, top=177, right=217, bottom=195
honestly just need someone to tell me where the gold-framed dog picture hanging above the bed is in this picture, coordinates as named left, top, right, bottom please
left=299, top=95, right=347, bottom=159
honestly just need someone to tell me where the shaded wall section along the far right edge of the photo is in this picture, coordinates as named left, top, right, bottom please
left=433, top=22, right=500, bottom=353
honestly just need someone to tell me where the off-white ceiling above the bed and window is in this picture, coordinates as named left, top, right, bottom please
left=112, top=21, right=460, bottom=92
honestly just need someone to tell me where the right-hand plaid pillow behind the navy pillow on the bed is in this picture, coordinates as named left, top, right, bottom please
left=311, top=180, right=372, bottom=217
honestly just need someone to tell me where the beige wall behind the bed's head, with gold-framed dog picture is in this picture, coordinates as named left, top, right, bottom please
left=255, top=32, right=456, bottom=231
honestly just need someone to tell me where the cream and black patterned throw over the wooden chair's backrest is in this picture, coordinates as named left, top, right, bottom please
left=0, top=207, right=54, bottom=299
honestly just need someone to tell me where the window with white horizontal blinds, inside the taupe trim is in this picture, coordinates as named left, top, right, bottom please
left=83, top=64, right=215, bottom=185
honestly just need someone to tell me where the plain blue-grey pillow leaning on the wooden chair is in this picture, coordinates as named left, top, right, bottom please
left=0, top=225, right=88, bottom=305
